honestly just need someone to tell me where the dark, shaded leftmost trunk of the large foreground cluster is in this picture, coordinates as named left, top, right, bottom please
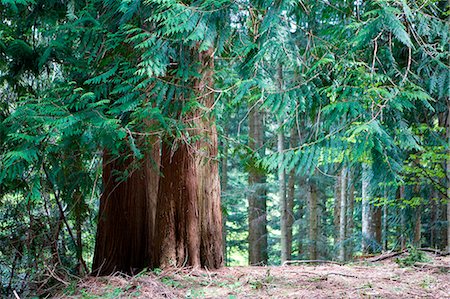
left=92, top=151, right=157, bottom=275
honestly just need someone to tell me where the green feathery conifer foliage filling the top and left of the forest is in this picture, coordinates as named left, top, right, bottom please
left=0, top=0, right=450, bottom=296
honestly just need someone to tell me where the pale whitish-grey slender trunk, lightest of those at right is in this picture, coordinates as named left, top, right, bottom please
left=361, top=163, right=372, bottom=253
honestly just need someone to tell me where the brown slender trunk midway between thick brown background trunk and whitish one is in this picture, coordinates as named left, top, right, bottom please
left=306, top=179, right=319, bottom=260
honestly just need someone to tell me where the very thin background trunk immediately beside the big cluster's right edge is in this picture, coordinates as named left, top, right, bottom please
left=220, top=128, right=228, bottom=266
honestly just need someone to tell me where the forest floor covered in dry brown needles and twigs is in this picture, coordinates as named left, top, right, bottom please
left=61, top=254, right=450, bottom=299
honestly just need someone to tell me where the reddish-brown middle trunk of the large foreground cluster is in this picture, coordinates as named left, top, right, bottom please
left=155, top=143, right=200, bottom=268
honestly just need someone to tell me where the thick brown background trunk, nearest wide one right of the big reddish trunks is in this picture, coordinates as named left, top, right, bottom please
left=248, top=106, right=268, bottom=265
